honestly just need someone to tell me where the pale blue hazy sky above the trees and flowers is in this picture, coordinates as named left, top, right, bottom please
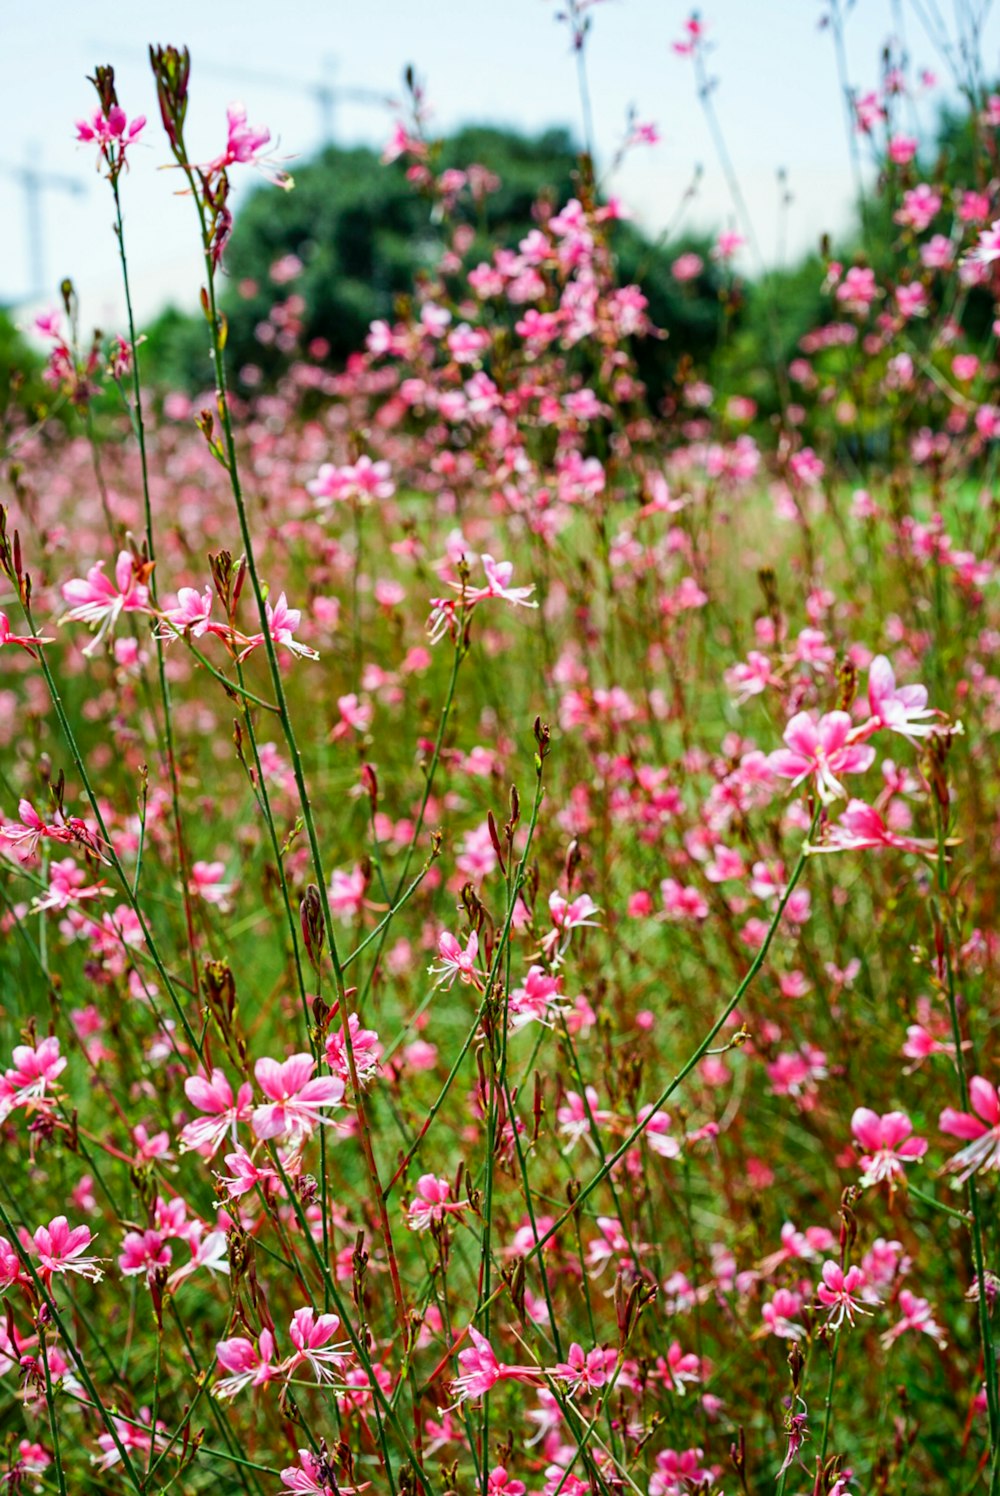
left=0, top=0, right=1000, bottom=326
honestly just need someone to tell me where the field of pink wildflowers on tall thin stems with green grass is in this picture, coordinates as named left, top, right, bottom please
left=0, top=11, right=1000, bottom=1496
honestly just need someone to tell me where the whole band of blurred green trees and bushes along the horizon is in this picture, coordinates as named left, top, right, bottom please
left=0, top=99, right=993, bottom=420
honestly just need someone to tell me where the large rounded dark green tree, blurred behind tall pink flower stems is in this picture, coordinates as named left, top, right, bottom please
left=140, top=126, right=730, bottom=399
